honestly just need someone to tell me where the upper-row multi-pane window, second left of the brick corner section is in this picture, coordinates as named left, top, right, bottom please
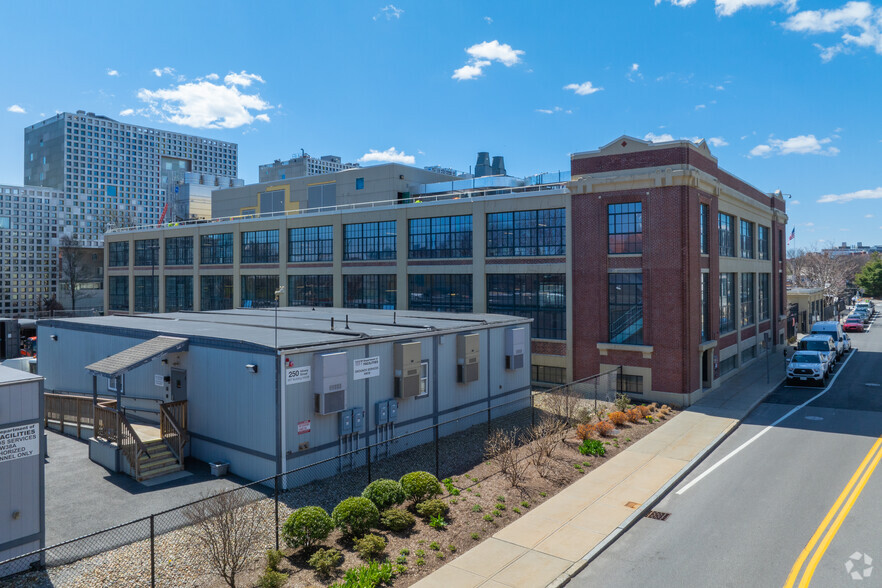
left=407, top=215, right=472, bottom=259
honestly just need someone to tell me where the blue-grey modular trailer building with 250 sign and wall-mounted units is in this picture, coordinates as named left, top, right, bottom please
left=37, top=307, right=531, bottom=480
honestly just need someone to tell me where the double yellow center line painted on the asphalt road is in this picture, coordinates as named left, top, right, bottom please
left=784, top=437, right=882, bottom=588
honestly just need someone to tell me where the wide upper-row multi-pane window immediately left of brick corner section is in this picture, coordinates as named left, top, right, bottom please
left=487, top=208, right=567, bottom=257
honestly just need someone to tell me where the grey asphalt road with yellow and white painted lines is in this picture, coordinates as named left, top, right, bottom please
left=570, top=310, right=882, bottom=588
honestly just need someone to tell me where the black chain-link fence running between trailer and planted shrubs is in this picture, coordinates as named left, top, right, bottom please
left=0, top=368, right=621, bottom=588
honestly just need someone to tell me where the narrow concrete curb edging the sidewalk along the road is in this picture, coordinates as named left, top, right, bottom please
left=546, top=379, right=784, bottom=588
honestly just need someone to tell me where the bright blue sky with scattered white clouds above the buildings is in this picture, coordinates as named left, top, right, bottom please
left=0, top=0, right=882, bottom=247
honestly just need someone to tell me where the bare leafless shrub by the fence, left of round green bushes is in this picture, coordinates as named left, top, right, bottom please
left=184, top=491, right=264, bottom=588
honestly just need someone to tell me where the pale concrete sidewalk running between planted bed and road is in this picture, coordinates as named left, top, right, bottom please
left=414, top=351, right=785, bottom=588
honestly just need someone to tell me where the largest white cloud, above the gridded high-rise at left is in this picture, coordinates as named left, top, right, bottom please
left=138, top=71, right=272, bottom=129
